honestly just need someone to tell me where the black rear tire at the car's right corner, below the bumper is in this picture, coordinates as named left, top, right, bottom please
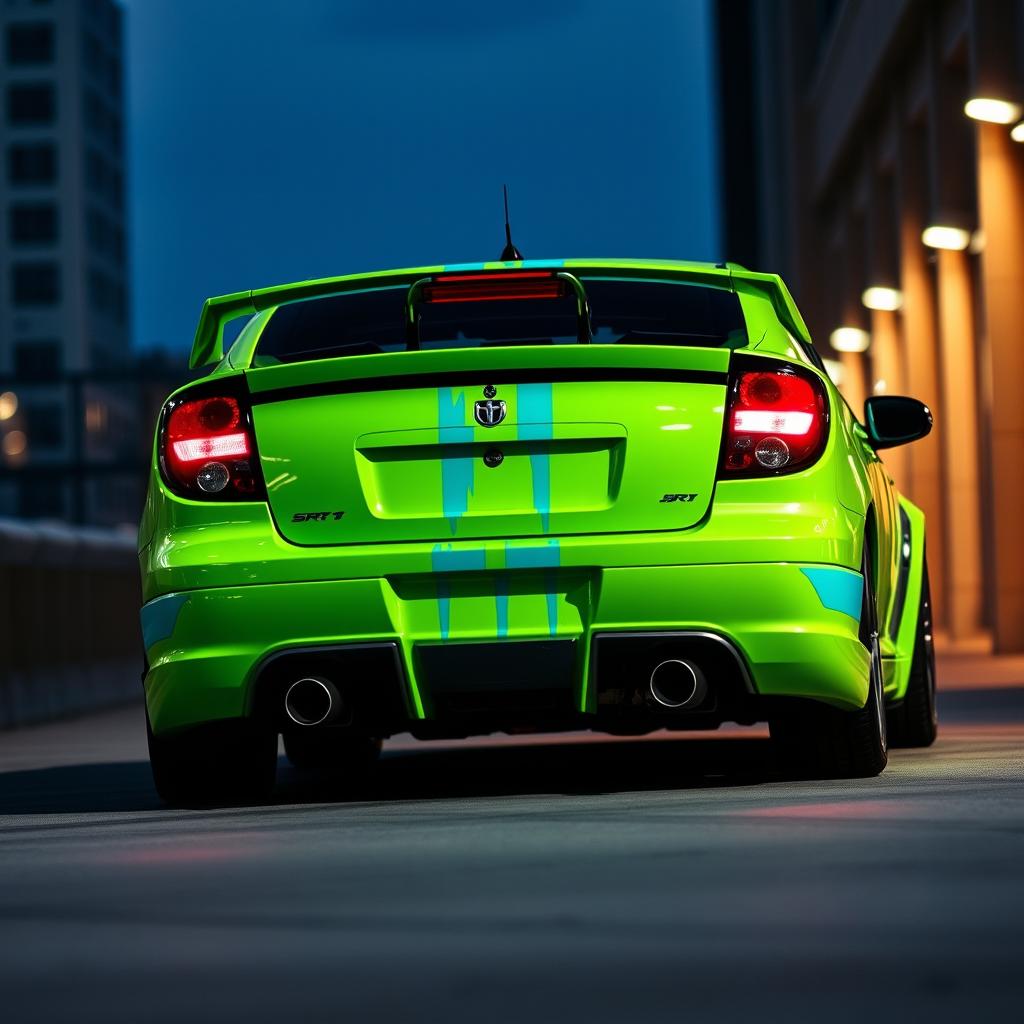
left=769, top=545, right=889, bottom=778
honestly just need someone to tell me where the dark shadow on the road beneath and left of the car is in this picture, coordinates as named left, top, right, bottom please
left=0, top=737, right=777, bottom=815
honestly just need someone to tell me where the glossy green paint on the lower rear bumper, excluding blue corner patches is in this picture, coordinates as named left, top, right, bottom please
left=146, top=565, right=867, bottom=731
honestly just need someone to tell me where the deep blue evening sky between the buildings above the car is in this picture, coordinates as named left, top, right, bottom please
left=125, top=0, right=721, bottom=353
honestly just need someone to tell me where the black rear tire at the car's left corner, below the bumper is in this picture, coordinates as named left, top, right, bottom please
left=145, top=715, right=278, bottom=807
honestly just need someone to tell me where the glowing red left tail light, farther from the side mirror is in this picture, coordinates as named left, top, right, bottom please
left=159, top=394, right=265, bottom=502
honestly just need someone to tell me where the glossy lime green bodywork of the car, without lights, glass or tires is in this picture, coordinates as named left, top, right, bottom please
left=139, top=260, right=924, bottom=732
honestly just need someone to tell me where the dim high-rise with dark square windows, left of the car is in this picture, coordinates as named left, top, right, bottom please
left=0, top=0, right=137, bottom=522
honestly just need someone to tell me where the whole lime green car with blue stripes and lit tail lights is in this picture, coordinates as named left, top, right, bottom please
left=139, top=259, right=936, bottom=802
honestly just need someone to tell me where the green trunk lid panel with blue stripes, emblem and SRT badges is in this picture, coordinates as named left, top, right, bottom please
left=253, top=368, right=728, bottom=545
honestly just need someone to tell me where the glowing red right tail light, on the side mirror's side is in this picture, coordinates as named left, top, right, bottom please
left=719, top=360, right=828, bottom=479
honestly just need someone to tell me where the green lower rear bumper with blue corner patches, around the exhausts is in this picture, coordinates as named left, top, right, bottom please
left=142, top=561, right=868, bottom=733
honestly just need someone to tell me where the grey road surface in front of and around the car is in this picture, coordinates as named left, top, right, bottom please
left=0, top=689, right=1024, bottom=1024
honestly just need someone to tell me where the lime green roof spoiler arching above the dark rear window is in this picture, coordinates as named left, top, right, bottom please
left=188, top=259, right=811, bottom=370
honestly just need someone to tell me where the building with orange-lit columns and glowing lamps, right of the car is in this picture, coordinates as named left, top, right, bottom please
left=716, top=0, right=1024, bottom=652
